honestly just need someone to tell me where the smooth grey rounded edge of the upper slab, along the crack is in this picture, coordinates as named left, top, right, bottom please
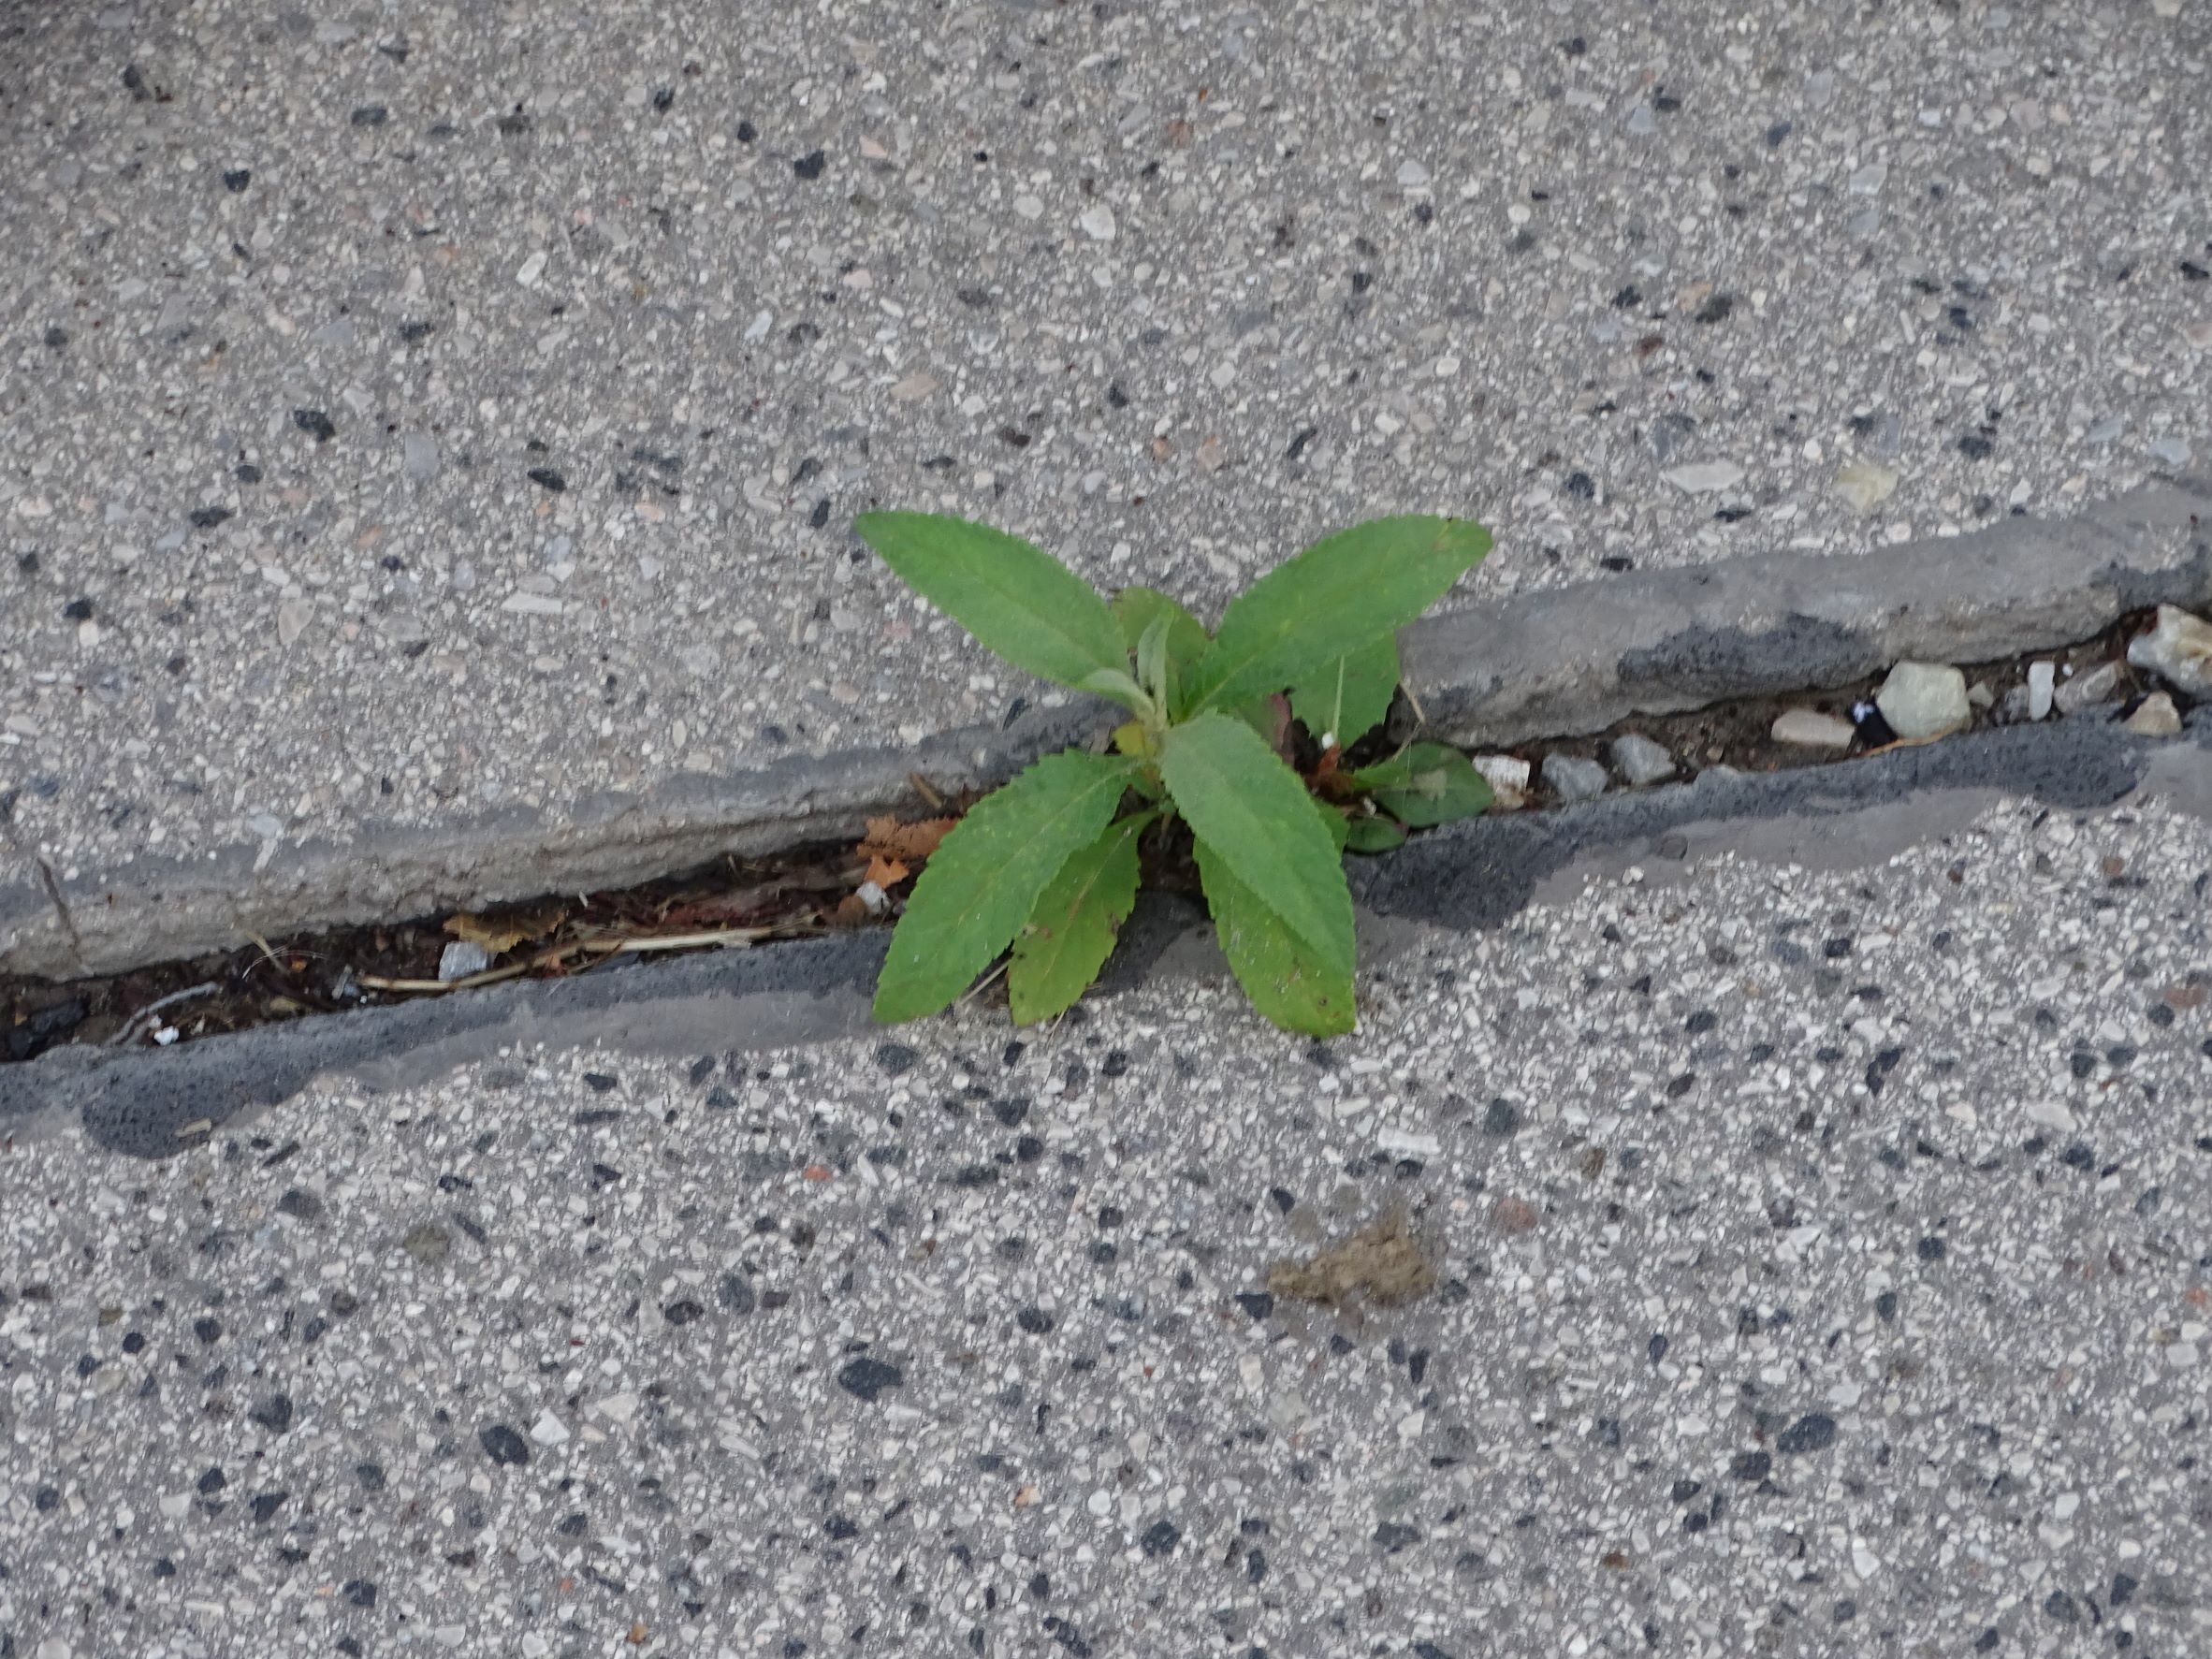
left=0, top=478, right=2212, bottom=978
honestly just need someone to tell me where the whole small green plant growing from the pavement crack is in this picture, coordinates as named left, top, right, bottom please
left=854, top=513, right=1491, bottom=1035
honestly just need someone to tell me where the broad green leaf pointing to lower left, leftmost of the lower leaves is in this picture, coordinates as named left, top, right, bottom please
left=876, top=749, right=1135, bottom=1022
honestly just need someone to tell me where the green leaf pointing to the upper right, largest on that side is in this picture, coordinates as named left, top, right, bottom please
left=1184, top=517, right=1491, bottom=710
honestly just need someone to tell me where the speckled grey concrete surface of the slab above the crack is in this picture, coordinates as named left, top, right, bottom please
left=0, top=0, right=2212, bottom=897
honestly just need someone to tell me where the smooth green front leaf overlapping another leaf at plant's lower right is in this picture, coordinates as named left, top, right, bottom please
left=1159, top=715, right=1354, bottom=978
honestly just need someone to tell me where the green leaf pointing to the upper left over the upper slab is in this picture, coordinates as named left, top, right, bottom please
left=851, top=513, right=1128, bottom=703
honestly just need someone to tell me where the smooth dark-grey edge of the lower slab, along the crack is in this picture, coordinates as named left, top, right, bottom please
left=0, top=710, right=2212, bottom=1157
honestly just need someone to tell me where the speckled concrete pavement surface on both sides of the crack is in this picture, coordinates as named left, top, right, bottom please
left=0, top=0, right=2212, bottom=1659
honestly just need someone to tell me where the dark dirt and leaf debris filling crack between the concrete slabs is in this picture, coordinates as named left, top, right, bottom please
left=0, top=615, right=2176, bottom=1064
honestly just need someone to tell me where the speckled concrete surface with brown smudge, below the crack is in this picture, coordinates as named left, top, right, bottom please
left=0, top=769, right=2212, bottom=1659
